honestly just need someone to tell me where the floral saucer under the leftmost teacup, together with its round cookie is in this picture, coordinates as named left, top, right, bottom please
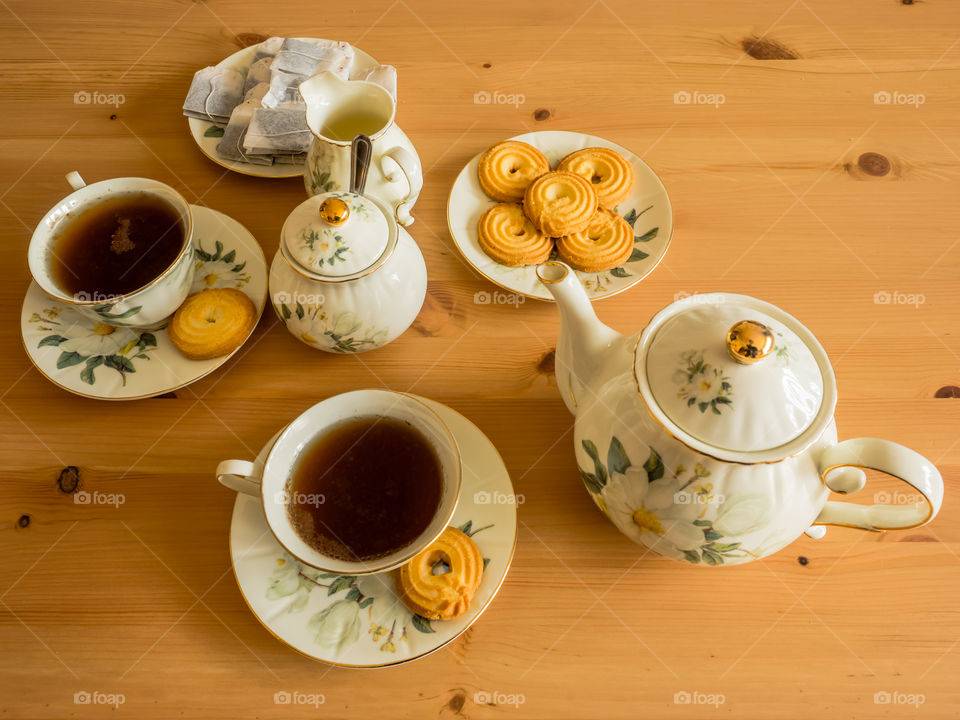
left=20, top=205, right=267, bottom=400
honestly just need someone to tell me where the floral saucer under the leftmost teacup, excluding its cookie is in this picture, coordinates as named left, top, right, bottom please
left=20, top=205, right=267, bottom=400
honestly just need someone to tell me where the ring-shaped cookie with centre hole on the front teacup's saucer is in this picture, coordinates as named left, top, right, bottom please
left=395, top=527, right=483, bottom=620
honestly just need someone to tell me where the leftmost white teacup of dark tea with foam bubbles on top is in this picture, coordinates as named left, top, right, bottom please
left=28, top=172, right=194, bottom=328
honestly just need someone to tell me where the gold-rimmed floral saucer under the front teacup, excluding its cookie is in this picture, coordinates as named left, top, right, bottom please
left=230, top=397, right=522, bottom=668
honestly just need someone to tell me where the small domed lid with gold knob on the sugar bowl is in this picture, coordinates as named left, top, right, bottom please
left=281, top=192, right=397, bottom=280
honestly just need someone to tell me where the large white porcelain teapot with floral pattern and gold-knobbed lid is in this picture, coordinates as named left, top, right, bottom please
left=537, top=262, right=943, bottom=566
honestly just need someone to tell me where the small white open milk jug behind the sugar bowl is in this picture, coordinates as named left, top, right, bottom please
left=300, top=72, right=423, bottom=225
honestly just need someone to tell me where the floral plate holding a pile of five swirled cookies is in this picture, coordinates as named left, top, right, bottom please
left=447, top=130, right=673, bottom=302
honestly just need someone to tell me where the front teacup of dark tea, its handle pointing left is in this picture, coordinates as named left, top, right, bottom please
left=217, top=390, right=461, bottom=575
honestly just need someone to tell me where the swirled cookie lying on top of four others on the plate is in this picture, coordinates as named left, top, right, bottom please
left=523, top=171, right=598, bottom=237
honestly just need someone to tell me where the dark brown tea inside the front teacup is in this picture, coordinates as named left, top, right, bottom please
left=287, top=416, right=442, bottom=561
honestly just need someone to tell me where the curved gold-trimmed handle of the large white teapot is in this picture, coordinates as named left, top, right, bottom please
left=813, top=438, right=943, bottom=532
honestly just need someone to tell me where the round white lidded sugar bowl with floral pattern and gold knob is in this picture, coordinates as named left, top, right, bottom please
left=270, top=186, right=427, bottom=353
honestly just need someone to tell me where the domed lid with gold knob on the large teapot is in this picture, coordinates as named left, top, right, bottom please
left=635, top=293, right=836, bottom=462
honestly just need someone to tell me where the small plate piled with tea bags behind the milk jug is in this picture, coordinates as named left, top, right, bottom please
left=183, top=37, right=380, bottom=178
